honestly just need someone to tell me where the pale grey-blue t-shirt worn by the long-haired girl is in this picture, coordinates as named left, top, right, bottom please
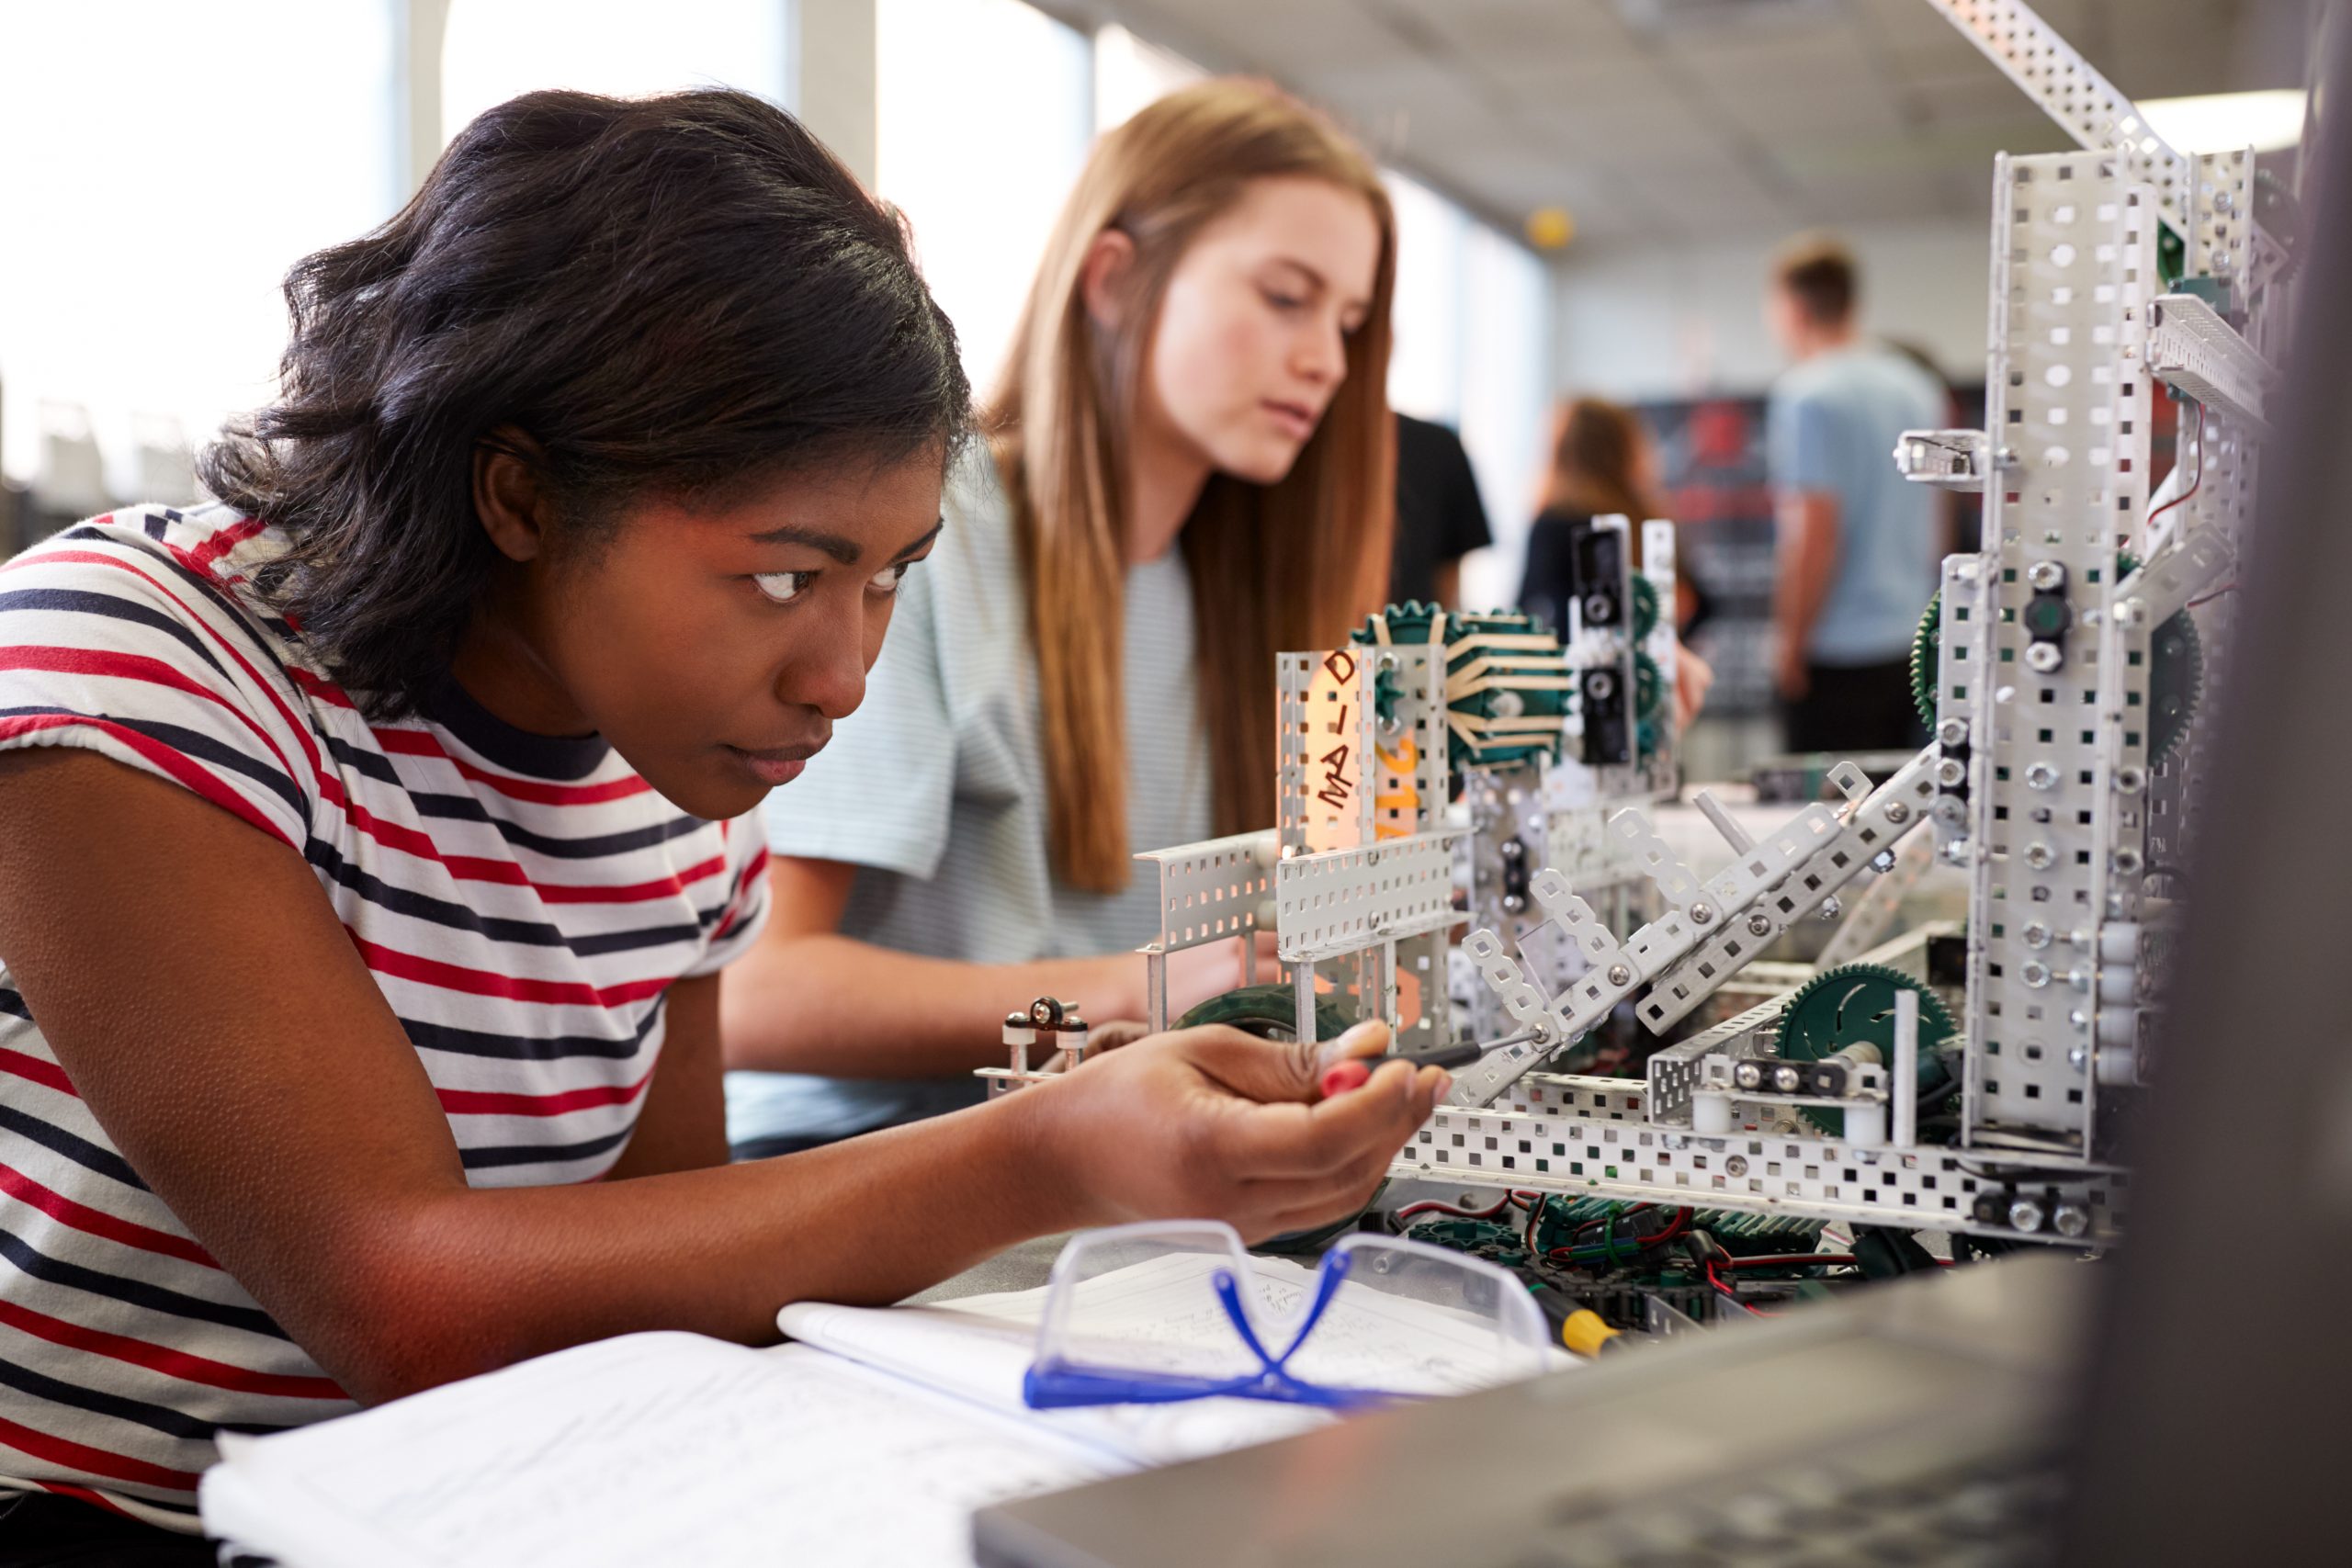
left=727, top=451, right=1213, bottom=1145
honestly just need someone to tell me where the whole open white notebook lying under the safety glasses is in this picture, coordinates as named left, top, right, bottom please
left=200, top=1258, right=1543, bottom=1568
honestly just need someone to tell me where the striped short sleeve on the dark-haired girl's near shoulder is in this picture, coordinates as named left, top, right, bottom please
left=0, top=522, right=324, bottom=853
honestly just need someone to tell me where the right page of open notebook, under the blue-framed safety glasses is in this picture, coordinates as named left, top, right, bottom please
left=776, top=1253, right=1569, bottom=1464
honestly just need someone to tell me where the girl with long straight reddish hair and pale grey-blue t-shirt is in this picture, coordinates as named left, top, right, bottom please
left=722, top=80, right=1395, bottom=1156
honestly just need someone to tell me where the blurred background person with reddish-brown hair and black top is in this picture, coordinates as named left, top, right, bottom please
left=1520, top=398, right=1714, bottom=724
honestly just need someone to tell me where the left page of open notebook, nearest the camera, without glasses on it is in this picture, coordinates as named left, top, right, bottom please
left=202, top=1333, right=1125, bottom=1568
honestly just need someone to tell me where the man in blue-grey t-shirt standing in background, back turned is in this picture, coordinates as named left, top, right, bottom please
left=1764, top=235, right=1948, bottom=752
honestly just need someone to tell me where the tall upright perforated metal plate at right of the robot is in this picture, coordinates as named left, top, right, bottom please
left=1938, top=152, right=2157, bottom=1152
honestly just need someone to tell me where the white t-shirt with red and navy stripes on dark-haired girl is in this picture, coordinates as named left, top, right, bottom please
left=0, top=508, right=767, bottom=1530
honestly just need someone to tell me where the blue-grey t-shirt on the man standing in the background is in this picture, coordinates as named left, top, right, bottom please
left=1764, top=344, right=1948, bottom=665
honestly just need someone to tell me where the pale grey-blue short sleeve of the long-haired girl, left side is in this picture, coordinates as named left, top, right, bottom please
left=764, top=536, right=957, bottom=882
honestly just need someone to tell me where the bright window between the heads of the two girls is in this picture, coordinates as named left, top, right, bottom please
left=875, top=0, right=1093, bottom=398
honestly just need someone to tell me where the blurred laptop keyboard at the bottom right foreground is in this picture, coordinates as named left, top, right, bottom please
left=1510, top=1438, right=2063, bottom=1568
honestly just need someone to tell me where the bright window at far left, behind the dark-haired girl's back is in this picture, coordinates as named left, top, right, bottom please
left=0, top=0, right=398, bottom=501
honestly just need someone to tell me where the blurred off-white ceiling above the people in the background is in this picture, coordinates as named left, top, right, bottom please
left=1042, top=0, right=2293, bottom=243
